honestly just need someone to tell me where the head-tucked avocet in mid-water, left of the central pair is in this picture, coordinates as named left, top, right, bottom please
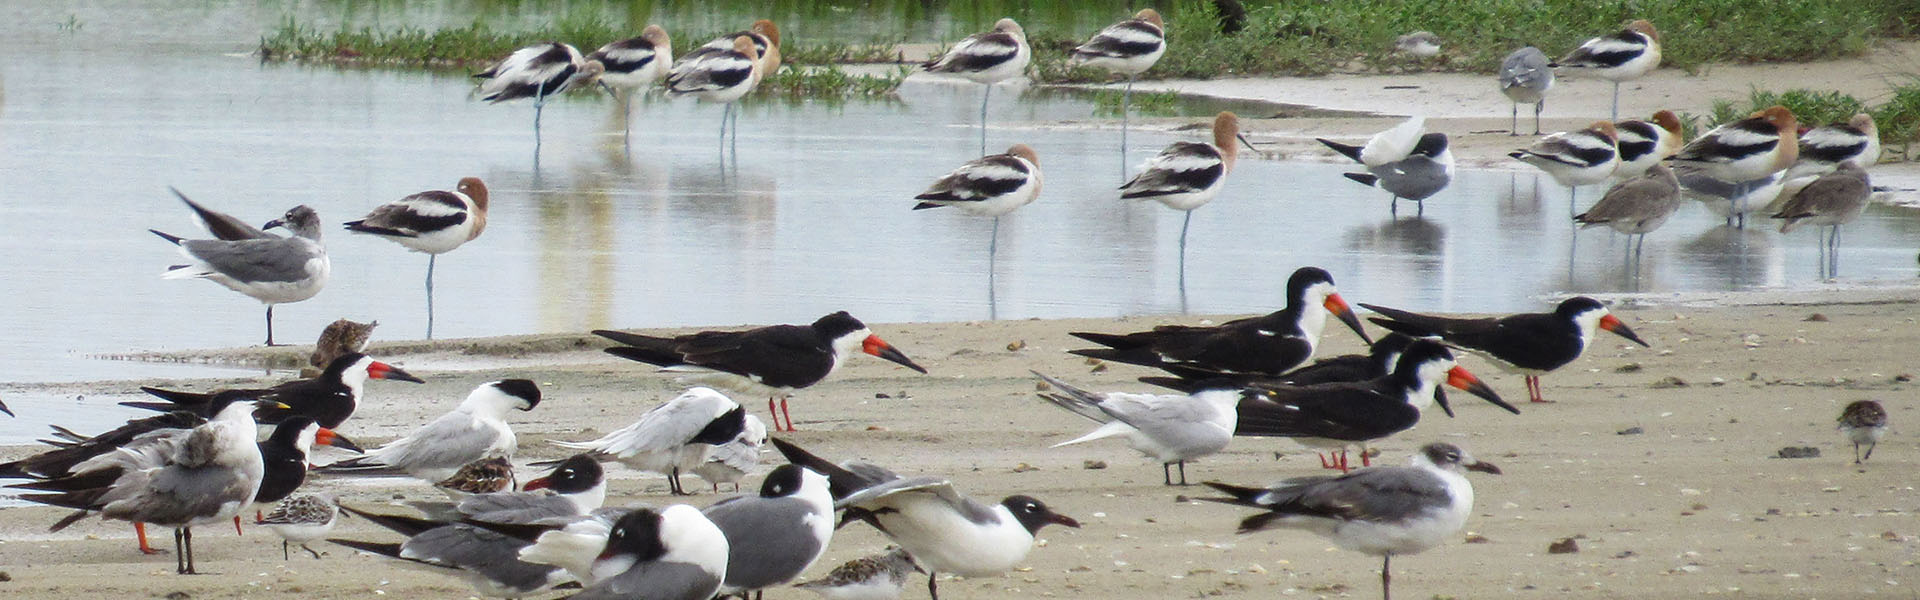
left=914, top=144, right=1041, bottom=254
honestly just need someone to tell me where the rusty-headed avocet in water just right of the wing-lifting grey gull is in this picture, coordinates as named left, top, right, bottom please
left=346, top=177, right=488, bottom=340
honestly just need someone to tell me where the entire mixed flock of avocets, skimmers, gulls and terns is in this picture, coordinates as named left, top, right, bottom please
left=0, top=10, right=1887, bottom=600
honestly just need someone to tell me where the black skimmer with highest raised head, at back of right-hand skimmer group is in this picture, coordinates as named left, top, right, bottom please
left=1071, top=267, right=1373, bottom=377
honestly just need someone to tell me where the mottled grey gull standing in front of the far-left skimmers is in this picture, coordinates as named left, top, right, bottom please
left=13, top=398, right=271, bottom=575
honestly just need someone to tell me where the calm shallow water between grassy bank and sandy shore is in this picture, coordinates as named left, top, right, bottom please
left=0, top=4, right=1920, bottom=388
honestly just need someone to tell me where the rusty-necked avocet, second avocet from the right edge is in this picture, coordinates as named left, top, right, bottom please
left=1668, top=106, right=1799, bottom=181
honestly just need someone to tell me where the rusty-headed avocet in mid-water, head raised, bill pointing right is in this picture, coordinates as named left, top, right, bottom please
left=1119, top=112, right=1254, bottom=256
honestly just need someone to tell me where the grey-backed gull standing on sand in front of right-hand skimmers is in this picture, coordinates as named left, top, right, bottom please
left=1200, top=442, right=1500, bottom=598
